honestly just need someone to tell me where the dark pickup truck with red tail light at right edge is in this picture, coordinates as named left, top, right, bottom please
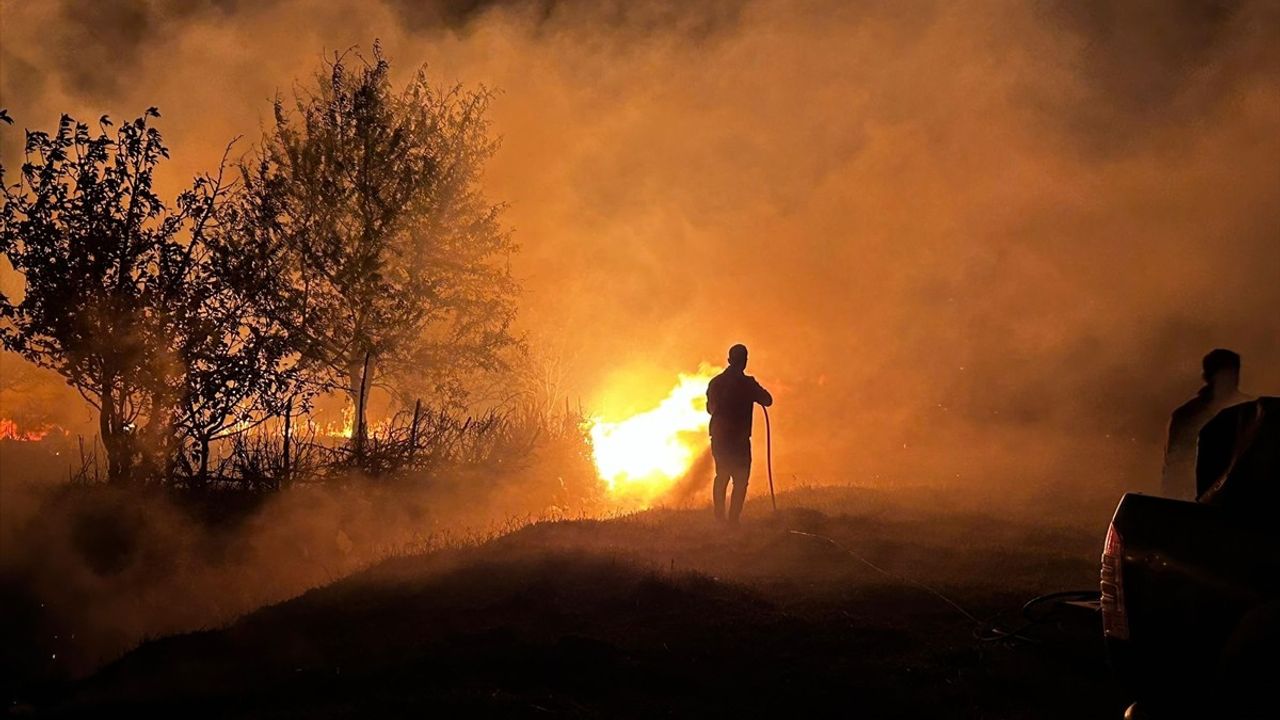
left=1101, top=398, right=1280, bottom=719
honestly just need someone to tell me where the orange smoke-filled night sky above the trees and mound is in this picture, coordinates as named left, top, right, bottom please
left=0, top=0, right=1280, bottom=507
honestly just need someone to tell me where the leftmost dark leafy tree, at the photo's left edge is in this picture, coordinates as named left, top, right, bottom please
left=0, top=108, right=186, bottom=482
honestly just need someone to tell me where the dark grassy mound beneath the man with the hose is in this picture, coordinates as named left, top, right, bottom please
left=22, top=491, right=1124, bottom=719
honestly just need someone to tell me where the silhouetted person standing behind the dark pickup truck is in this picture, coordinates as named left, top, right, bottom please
left=1161, top=348, right=1252, bottom=500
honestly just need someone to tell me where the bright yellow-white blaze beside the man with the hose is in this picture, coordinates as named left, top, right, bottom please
left=590, top=365, right=718, bottom=505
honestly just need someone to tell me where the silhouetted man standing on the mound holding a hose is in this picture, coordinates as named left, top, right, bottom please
left=707, top=345, right=773, bottom=524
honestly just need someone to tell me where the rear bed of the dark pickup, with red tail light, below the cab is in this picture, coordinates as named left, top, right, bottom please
left=1102, top=493, right=1280, bottom=712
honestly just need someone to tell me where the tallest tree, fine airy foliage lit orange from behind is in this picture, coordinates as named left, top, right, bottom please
left=243, top=45, right=516, bottom=451
